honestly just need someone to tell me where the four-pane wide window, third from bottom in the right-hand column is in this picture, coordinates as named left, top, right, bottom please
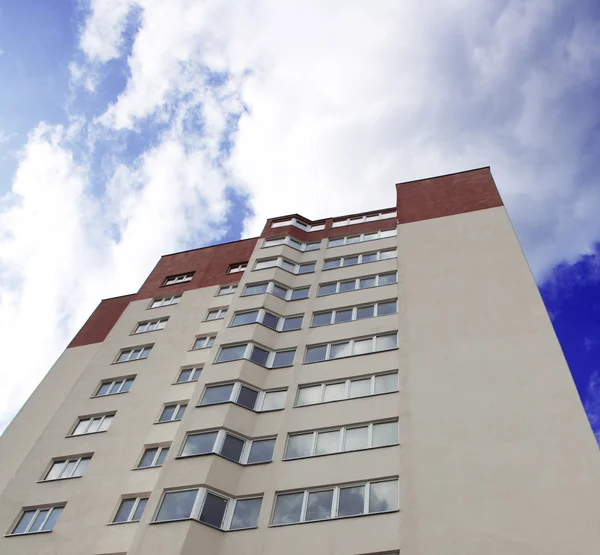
left=296, top=372, right=398, bottom=407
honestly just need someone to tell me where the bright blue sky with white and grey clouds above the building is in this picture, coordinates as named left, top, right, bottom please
left=0, top=0, right=600, bottom=438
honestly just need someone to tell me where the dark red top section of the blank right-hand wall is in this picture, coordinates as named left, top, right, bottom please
left=396, top=167, right=502, bottom=224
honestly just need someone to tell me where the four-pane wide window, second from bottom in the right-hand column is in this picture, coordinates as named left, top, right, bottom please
left=284, top=420, right=398, bottom=460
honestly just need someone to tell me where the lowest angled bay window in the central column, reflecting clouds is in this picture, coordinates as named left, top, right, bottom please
left=155, top=488, right=262, bottom=530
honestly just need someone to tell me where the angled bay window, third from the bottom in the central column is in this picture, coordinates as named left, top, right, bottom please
left=199, top=382, right=287, bottom=412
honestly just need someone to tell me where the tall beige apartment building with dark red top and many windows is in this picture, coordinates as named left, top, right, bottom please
left=0, top=168, right=600, bottom=555
